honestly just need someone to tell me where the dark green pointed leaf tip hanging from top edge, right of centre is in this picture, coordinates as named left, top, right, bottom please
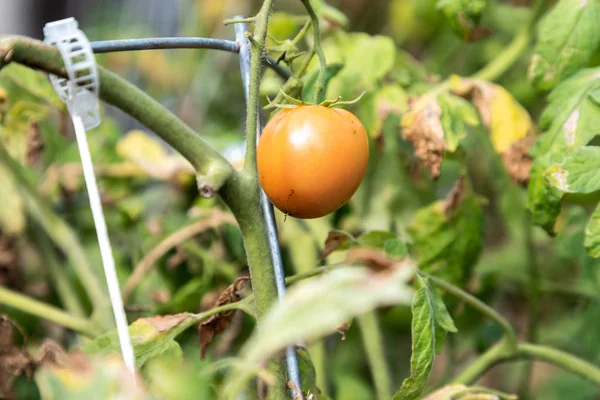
left=437, top=0, right=486, bottom=40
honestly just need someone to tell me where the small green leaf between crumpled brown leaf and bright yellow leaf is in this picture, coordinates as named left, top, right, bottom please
left=438, top=95, right=479, bottom=152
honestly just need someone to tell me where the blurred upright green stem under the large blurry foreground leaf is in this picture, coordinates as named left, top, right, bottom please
left=358, top=311, right=392, bottom=400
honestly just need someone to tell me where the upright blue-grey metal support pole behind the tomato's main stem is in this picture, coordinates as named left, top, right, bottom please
left=235, top=16, right=302, bottom=397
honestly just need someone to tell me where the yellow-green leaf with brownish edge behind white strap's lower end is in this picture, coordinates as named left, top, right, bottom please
left=83, top=313, right=197, bottom=367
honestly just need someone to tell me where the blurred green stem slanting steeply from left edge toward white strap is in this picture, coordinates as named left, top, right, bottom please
left=0, top=144, right=114, bottom=329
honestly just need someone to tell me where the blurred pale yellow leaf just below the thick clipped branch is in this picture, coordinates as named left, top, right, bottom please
left=116, top=130, right=194, bottom=180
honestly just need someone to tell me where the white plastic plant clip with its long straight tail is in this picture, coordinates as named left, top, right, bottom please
left=44, top=18, right=135, bottom=377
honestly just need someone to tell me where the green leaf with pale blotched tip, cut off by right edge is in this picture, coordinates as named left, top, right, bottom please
left=544, top=146, right=600, bottom=193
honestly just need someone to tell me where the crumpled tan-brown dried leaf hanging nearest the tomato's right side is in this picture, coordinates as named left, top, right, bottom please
left=401, top=97, right=446, bottom=179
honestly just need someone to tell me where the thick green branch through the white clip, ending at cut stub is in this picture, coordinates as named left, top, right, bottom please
left=0, top=35, right=234, bottom=195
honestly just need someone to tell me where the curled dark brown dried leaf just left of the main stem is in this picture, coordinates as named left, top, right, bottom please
left=198, top=276, right=250, bottom=360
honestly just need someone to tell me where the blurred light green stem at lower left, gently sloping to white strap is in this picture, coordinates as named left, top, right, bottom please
left=0, top=286, right=100, bottom=338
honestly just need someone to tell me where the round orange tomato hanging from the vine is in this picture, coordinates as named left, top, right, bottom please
left=257, top=105, right=369, bottom=219
